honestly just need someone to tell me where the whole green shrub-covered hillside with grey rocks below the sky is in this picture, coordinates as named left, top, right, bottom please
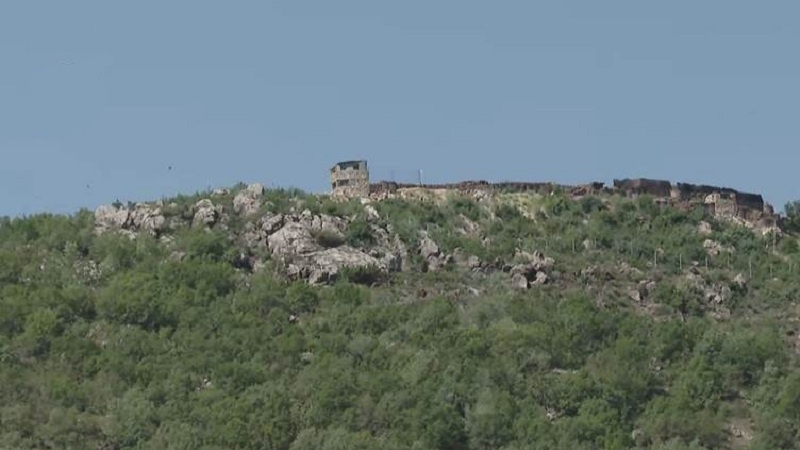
left=0, top=180, right=800, bottom=450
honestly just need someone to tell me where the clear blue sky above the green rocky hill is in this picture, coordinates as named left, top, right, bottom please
left=0, top=0, right=800, bottom=215
